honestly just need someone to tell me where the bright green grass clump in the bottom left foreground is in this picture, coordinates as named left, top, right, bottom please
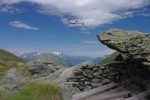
left=0, top=82, right=61, bottom=100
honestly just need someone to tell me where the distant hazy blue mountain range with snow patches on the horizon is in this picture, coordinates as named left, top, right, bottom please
left=17, top=52, right=102, bottom=66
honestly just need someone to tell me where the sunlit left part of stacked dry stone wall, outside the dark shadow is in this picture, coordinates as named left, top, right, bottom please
left=67, top=65, right=118, bottom=91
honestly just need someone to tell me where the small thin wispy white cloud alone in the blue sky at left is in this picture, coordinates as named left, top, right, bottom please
left=10, top=21, right=39, bottom=31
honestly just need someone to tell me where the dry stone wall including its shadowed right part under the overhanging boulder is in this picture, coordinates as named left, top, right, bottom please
left=67, top=61, right=150, bottom=91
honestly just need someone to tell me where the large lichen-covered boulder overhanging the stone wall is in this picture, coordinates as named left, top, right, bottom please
left=98, top=30, right=150, bottom=66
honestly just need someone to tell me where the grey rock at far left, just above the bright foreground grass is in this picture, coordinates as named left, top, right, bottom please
left=2, top=68, right=29, bottom=91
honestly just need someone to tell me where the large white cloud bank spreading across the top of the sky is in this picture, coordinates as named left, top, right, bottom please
left=0, top=0, right=150, bottom=27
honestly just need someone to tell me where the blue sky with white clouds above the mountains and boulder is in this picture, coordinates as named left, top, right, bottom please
left=0, top=0, right=150, bottom=57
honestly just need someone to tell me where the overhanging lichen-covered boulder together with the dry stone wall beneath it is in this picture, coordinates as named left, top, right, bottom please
left=64, top=30, right=150, bottom=98
